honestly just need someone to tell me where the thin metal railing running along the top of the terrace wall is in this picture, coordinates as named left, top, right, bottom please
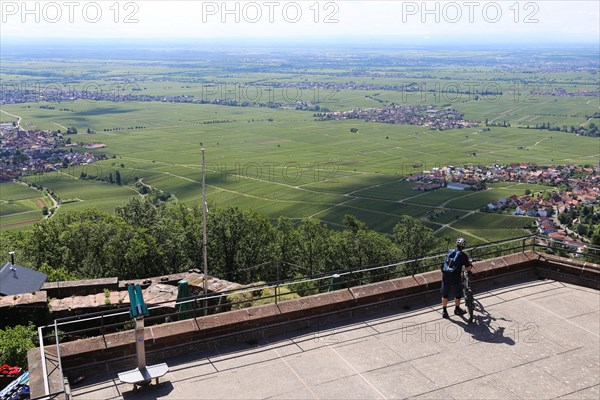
left=38, top=235, right=600, bottom=395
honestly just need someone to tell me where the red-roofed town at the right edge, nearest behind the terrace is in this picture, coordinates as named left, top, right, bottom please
left=406, top=163, right=600, bottom=247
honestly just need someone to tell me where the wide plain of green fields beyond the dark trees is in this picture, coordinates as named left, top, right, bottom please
left=0, top=51, right=600, bottom=242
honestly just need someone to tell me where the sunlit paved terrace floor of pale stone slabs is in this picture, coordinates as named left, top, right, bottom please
left=72, top=280, right=600, bottom=400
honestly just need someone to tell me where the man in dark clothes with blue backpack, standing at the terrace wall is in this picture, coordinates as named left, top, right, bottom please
left=441, top=238, right=473, bottom=318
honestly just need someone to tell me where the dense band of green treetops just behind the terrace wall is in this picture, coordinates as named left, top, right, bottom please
left=0, top=197, right=447, bottom=284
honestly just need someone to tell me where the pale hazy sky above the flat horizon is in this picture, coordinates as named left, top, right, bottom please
left=0, top=0, right=600, bottom=43
